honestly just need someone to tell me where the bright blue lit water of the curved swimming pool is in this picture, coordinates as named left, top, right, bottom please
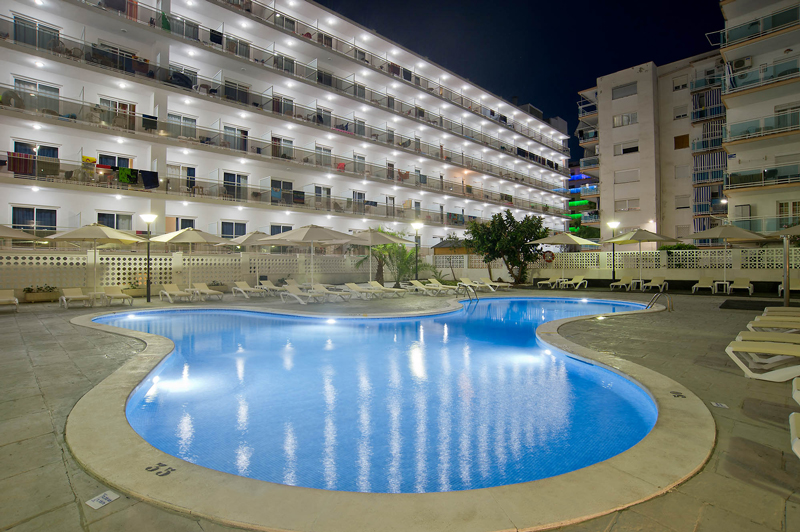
left=101, top=299, right=658, bottom=493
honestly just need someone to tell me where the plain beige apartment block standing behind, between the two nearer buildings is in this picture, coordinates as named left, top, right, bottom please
left=576, top=52, right=721, bottom=246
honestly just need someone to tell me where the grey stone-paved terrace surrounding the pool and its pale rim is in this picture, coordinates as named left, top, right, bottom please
left=0, top=290, right=800, bottom=532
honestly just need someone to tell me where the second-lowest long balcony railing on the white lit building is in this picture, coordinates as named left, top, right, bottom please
left=0, top=85, right=568, bottom=215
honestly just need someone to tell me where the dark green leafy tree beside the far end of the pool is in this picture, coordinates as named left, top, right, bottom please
left=465, top=210, right=548, bottom=284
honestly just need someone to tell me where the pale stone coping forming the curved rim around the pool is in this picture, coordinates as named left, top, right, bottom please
left=65, top=294, right=716, bottom=532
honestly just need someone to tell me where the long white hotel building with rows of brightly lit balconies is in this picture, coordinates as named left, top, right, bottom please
left=0, top=0, right=569, bottom=246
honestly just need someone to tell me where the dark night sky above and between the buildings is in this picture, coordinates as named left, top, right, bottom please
left=317, top=0, right=724, bottom=160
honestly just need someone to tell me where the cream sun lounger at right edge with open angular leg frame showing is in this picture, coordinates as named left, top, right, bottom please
left=725, top=341, right=800, bottom=382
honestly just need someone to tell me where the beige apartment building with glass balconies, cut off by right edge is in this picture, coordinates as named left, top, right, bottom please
left=708, top=0, right=800, bottom=232
